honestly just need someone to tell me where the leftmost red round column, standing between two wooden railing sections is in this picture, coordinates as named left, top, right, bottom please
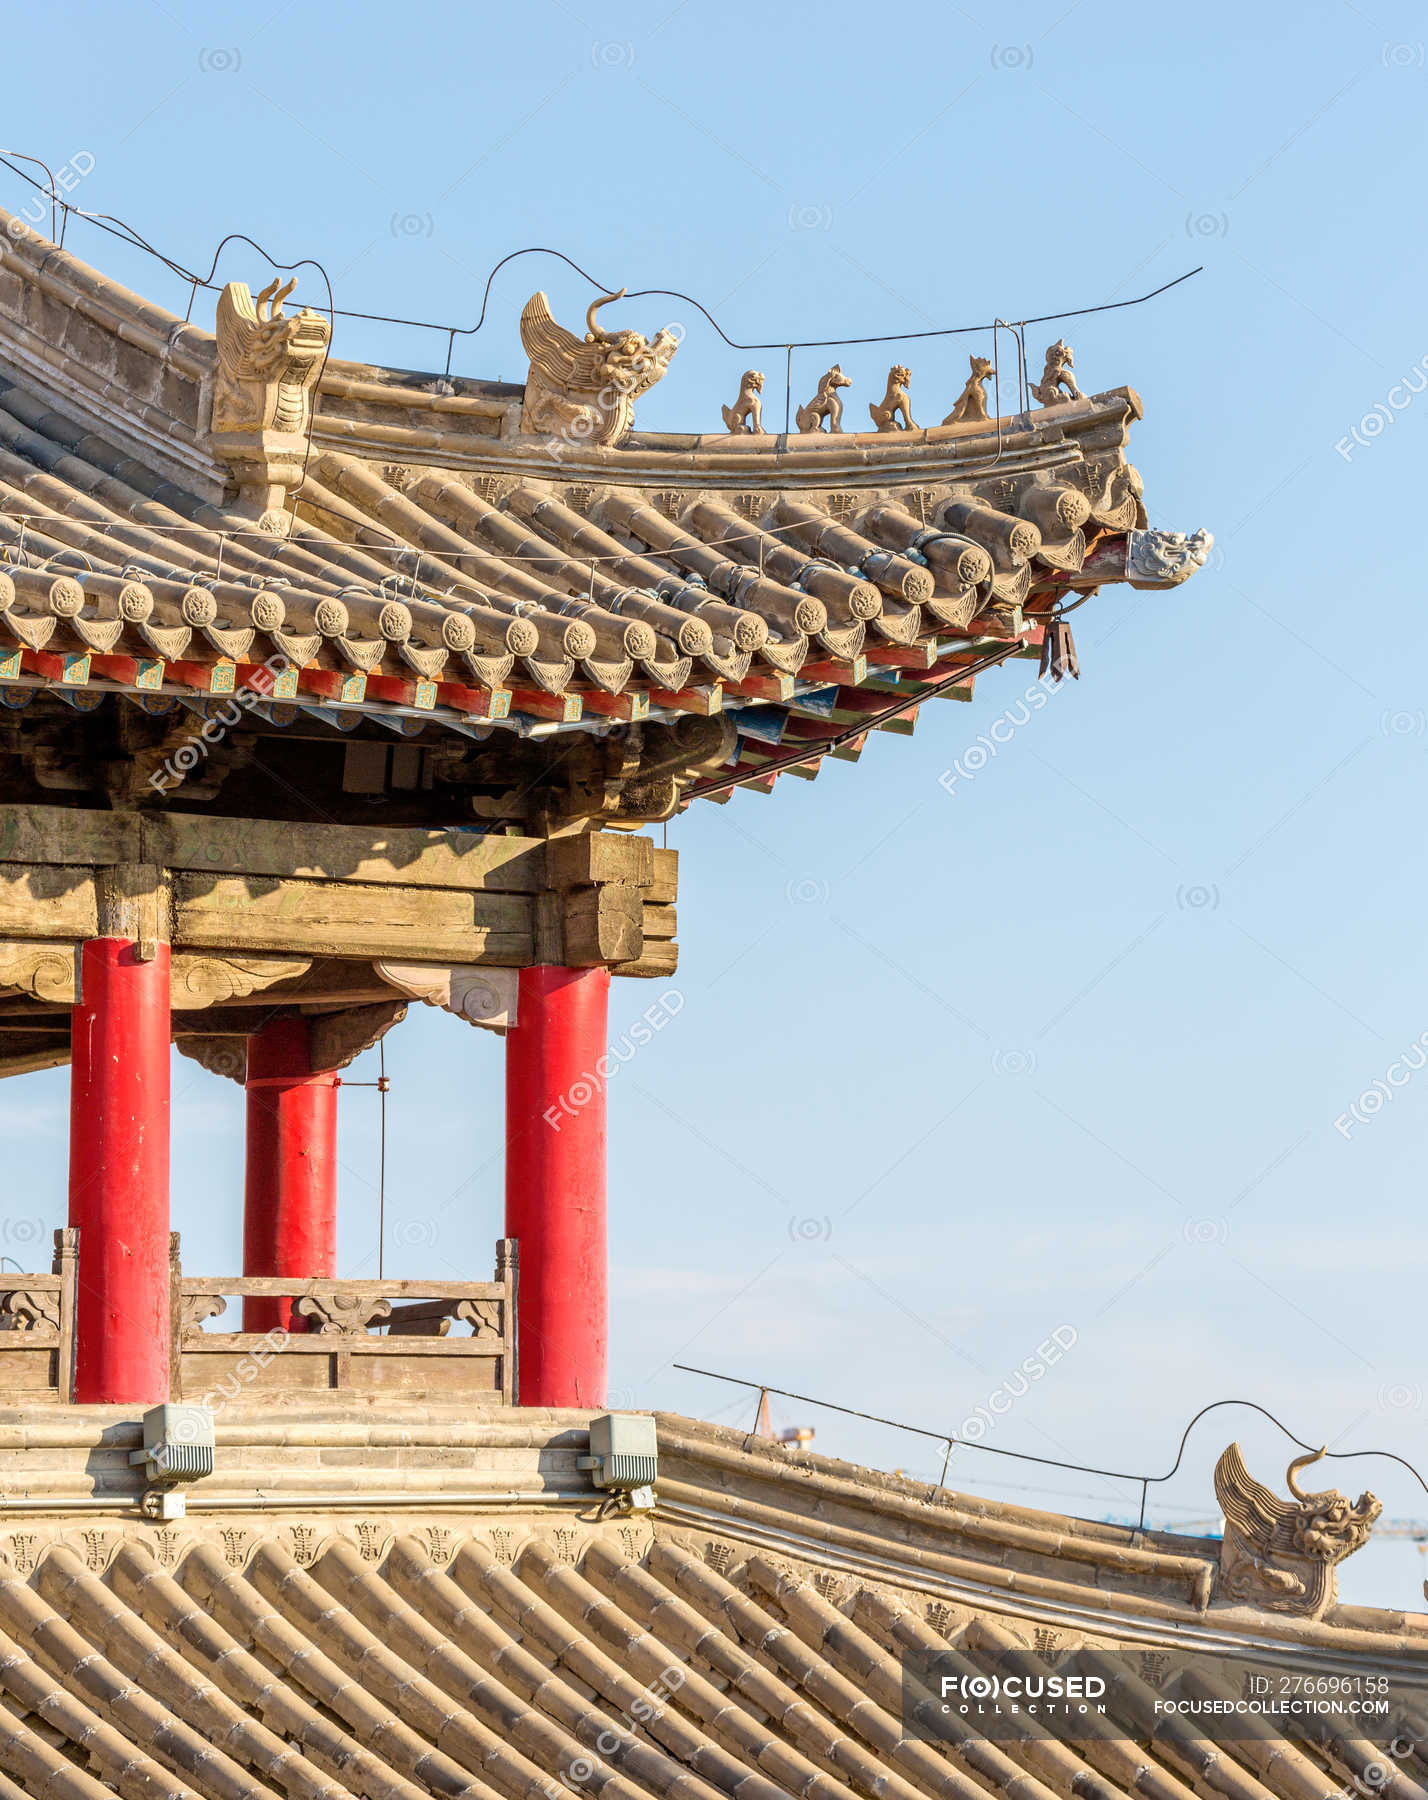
left=70, top=938, right=169, bottom=1406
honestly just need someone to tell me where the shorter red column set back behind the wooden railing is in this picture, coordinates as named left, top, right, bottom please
left=243, top=1019, right=337, bottom=1332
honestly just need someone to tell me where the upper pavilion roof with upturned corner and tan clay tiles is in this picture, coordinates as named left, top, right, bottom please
left=0, top=214, right=1203, bottom=817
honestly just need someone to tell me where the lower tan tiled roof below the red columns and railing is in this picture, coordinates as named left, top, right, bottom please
left=0, top=1406, right=1428, bottom=1800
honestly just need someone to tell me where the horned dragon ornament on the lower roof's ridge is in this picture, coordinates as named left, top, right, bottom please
left=1216, top=1444, right=1383, bottom=1618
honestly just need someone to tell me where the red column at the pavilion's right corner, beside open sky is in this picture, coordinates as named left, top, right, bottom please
left=506, top=967, right=610, bottom=1406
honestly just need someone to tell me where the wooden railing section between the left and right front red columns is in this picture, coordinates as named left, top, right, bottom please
left=169, top=1233, right=517, bottom=1406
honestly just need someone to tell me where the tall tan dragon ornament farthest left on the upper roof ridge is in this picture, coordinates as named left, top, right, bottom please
left=212, top=277, right=331, bottom=529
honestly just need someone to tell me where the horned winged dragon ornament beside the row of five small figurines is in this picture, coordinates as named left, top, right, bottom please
left=520, top=288, right=679, bottom=446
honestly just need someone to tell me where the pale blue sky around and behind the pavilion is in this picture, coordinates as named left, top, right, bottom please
left=0, top=0, right=1428, bottom=1607
